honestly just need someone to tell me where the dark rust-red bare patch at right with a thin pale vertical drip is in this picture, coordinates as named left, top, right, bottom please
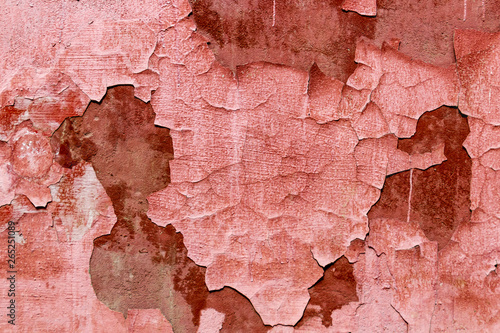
left=368, top=106, right=472, bottom=249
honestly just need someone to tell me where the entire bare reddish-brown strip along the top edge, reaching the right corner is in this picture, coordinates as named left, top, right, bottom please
left=190, top=0, right=500, bottom=81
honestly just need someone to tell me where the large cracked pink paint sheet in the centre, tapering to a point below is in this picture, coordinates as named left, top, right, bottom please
left=148, top=28, right=450, bottom=325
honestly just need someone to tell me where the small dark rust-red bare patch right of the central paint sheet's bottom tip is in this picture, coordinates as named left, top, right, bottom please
left=296, top=256, right=359, bottom=327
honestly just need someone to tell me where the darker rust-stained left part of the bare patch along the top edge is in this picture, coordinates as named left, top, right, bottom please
left=190, top=0, right=377, bottom=81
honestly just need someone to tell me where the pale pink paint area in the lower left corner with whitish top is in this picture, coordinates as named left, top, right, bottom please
left=0, top=164, right=120, bottom=332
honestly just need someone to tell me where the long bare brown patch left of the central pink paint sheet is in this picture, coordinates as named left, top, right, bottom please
left=51, top=86, right=269, bottom=332
